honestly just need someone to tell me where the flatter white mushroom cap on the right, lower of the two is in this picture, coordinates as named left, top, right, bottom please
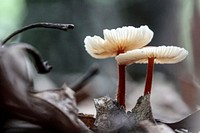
left=115, top=46, right=188, bottom=65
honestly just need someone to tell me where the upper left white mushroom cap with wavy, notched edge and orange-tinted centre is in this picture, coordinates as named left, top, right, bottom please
left=84, top=26, right=153, bottom=58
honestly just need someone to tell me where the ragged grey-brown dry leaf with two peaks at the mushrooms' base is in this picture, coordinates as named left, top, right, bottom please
left=94, top=95, right=173, bottom=133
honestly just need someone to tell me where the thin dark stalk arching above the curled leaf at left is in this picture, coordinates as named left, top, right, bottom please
left=2, top=22, right=74, bottom=45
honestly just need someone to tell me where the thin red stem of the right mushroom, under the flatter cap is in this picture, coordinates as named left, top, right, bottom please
left=144, top=57, right=154, bottom=96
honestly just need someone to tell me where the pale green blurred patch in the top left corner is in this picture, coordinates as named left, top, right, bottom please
left=0, top=0, right=26, bottom=39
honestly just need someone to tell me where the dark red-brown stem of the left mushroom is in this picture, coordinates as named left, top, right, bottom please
left=117, top=65, right=126, bottom=108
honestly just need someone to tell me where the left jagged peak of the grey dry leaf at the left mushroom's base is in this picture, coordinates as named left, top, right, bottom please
left=94, top=97, right=150, bottom=133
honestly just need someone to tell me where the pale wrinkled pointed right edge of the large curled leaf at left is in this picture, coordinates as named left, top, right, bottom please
left=34, top=84, right=90, bottom=132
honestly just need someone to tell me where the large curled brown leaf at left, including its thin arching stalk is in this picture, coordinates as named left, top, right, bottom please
left=0, top=23, right=92, bottom=133
